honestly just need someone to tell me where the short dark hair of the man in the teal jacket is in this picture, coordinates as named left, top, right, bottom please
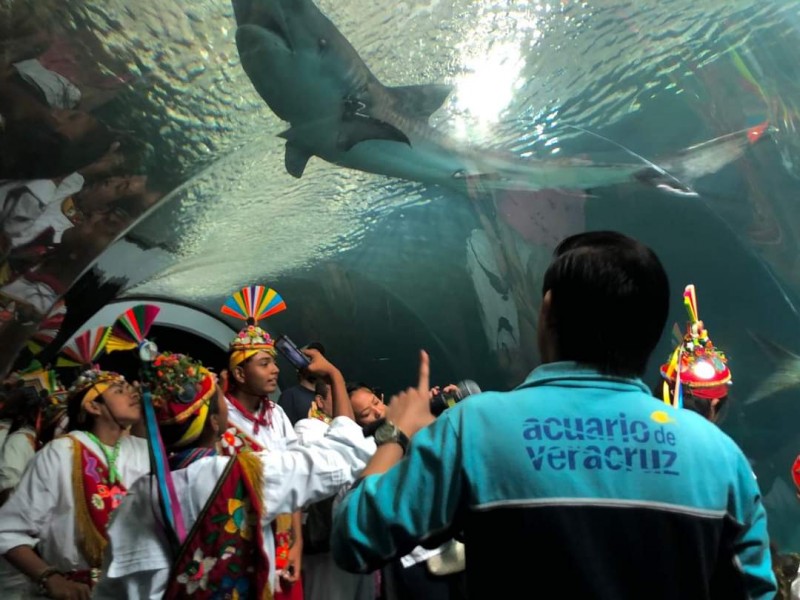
left=542, top=231, right=669, bottom=377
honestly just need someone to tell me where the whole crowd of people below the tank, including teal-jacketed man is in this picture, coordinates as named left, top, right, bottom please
left=0, top=231, right=800, bottom=600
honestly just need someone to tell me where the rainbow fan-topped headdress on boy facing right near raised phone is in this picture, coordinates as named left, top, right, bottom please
left=220, top=285, right=286, bottom=369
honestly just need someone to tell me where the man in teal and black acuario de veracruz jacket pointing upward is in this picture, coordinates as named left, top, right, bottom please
left=331, top=232, right=776, bottom=600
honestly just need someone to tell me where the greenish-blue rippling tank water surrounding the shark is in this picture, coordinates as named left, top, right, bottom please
left=0, top=0, right=800, bottom=550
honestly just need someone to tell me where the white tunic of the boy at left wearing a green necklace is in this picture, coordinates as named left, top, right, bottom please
left=0, top=431, right=150, bottom=596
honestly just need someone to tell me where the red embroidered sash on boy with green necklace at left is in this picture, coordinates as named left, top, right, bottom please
left=70, top=436, right=127, bottom=569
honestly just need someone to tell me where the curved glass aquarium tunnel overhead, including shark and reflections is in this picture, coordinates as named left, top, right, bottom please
left=0, top=0, right=800, bottom=551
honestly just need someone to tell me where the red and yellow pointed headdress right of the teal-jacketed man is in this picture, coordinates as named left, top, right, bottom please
left=661, top=285, right=731, bottom=408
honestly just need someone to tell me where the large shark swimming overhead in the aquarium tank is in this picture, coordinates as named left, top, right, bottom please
left=233, top=0, right=768, bottom=195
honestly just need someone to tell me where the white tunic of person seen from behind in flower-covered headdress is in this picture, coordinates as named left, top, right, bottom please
left=93, top=417, right=372, bottom=600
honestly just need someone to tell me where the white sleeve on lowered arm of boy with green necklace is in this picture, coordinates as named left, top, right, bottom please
left=0, top=444, right=64, bottom=554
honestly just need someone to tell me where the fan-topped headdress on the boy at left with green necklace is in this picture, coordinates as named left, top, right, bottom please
left=61, top=327, right=125, bottom=407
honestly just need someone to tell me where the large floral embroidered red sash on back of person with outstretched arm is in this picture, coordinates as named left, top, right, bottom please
left=164, top=452, right=272, bottom=600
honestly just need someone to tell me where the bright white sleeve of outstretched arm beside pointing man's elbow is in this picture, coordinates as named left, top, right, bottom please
left=260, top=417, right=375, bottom=521
